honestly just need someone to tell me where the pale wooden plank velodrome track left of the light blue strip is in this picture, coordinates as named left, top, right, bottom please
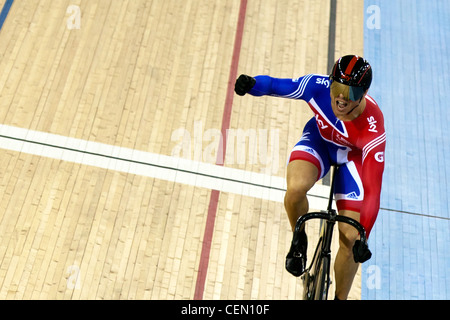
left=0, top=0, right=364, bottom=299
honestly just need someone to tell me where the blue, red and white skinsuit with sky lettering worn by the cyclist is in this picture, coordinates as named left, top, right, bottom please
left=249, top=74, right=386, bottom=236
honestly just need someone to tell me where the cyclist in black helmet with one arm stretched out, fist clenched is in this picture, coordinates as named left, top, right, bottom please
left=235, top=55, right=386, bottom=300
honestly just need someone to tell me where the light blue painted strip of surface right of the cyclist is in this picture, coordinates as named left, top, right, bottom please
left=362, top=0, right=450, bottom=299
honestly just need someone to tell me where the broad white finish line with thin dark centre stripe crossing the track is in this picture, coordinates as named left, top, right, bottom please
left=0, top=125, right=329, bottom=209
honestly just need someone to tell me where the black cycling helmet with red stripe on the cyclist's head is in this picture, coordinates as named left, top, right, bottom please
left=330, top=55, right=372, bottom=101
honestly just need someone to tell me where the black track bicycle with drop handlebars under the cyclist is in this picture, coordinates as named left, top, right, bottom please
left=292, top=166, right=372, bottom=300
